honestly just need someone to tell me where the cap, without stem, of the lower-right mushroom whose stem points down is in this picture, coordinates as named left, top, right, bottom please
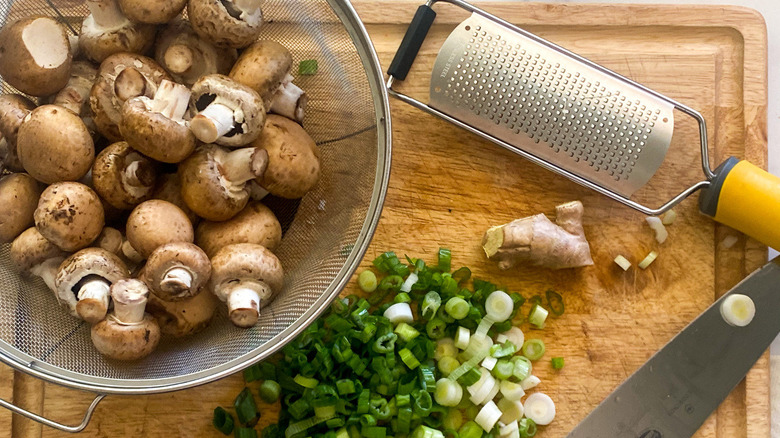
left=209, top=243, right=284, bottom=307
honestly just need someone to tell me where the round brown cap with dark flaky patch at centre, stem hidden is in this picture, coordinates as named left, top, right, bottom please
left=33, top=182, right=105, bottom=251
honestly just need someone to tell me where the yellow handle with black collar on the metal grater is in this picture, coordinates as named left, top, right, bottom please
left=699, top=157, right=780, bottom=250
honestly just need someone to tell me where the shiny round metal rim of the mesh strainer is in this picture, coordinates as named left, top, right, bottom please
left=0, top=0, right=392, bottom=395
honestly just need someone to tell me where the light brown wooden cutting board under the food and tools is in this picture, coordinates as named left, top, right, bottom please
left=0, top=0, right=770, bottom=438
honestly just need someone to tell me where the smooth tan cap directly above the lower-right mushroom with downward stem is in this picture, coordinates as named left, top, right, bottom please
left=195, top=201, right=282, bottom=257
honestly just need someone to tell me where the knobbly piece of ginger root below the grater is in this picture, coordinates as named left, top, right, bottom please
left=482, top=201, right=593, bottom=269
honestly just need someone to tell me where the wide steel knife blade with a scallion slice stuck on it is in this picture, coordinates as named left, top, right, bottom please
left=568, top=256, right=780, bottom=438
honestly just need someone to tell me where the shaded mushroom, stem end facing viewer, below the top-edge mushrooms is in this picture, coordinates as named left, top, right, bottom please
left=154, top=19, right=238, bottom=86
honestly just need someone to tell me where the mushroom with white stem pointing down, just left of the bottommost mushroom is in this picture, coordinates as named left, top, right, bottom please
left=56, top=248, right=130, bottom=324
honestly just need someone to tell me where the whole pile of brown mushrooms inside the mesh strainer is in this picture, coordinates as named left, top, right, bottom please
left=0, top=0, right=320, bottom=360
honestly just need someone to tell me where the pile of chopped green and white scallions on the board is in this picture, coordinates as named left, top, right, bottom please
left=213, top=248, right=563, bottom=438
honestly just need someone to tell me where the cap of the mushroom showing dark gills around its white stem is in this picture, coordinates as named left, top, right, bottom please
left=192, top=74, right=266, bottom=147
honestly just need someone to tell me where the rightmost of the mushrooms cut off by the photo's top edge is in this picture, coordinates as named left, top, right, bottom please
left=187, top=0, right=263, bottom=49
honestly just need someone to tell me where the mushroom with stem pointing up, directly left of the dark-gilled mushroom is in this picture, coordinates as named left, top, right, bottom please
left=119, top=80, right=195, bottom=163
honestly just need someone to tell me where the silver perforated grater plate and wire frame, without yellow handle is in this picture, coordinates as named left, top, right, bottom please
left=386, top=0, right=714, bottom=215
